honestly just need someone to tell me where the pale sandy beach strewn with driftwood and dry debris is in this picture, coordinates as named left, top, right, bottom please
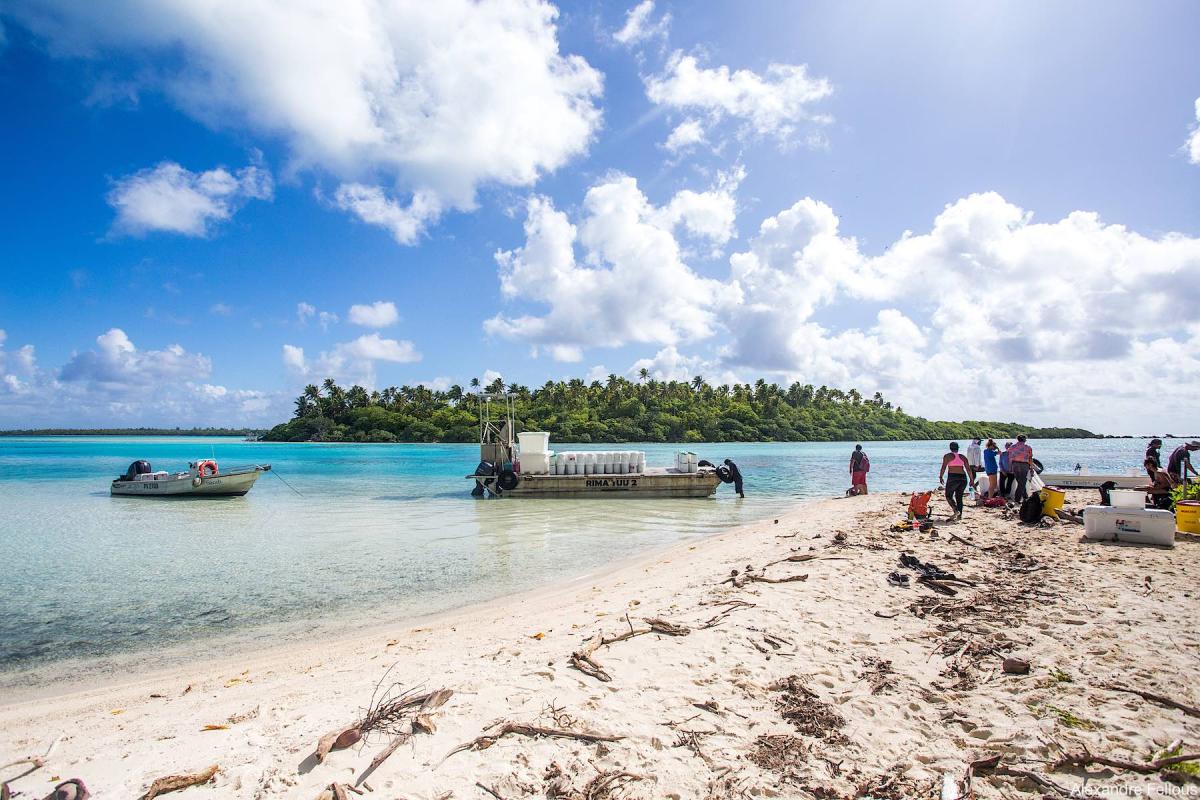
left=0, top=492, right=1200, bottom=800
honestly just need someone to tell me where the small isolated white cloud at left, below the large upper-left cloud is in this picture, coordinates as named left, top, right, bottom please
left=108, top=161, right=275, bottom=236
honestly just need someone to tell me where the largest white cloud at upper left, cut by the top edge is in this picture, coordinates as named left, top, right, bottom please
left=8, top=0, right=602, bottom=243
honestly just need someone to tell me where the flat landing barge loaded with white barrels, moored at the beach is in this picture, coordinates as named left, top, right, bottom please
left=467, top=393, right=734, bottom=498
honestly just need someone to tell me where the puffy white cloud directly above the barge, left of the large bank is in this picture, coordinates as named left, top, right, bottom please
left=485, top=175, right=736, bottom=361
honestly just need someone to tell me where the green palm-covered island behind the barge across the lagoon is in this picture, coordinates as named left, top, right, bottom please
left=265, top=371, right=1094, bottom=443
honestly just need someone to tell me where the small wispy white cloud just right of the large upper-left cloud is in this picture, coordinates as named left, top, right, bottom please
left=646, top=52, right=833, bottom=142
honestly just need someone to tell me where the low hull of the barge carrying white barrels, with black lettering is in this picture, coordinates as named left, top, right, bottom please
left=470, top=470, right=721, bottom=498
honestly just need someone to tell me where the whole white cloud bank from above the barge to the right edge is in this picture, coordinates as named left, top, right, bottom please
left=485, top=175, right=1200, bottom=432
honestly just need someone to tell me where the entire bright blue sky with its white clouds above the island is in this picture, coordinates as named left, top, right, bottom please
left=0, top=0, right=1200, bottom=433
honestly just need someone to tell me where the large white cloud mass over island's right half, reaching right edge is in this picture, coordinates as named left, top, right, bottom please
left=721, top=193, right=1200, bottom=432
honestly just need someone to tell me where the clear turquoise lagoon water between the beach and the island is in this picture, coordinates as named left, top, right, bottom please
left=0, top=437, right=1145, bottom=690
